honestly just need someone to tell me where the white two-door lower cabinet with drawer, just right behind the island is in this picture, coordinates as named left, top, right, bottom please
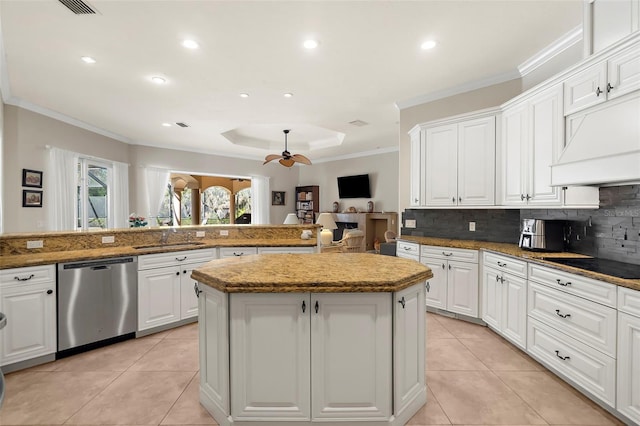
left=420, top=245, right=478, bottom=318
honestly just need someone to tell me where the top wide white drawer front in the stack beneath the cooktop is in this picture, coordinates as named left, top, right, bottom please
left=529, top=263, right=617, bottom=308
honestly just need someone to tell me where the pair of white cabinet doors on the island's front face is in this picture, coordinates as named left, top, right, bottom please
left=230, top=293, right=391, bottom=421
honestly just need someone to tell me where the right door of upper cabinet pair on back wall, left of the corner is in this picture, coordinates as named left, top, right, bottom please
left=457, top=117, right=496, bottom=206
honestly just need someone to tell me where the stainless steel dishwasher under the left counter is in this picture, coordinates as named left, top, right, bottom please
left=57, top=256, right=138, bottom=357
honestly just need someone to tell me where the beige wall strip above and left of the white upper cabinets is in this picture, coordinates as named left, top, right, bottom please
left=398, top=79, right=522, bottom=212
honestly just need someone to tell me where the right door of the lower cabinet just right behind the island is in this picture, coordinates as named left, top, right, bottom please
left=447, top=260, right=478, bottom=318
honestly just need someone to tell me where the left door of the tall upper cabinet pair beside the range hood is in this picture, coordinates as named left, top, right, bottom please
left=500, top=102, right=528, bottom=205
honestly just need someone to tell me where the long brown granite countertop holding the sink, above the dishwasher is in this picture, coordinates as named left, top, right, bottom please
left=0, top=238, right=317, bottom=269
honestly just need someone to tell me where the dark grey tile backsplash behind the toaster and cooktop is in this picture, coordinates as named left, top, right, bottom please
left=401, top=185, right=640, bottom=264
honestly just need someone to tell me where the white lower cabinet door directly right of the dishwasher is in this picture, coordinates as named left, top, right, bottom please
left=138, top=266, right=181, bottom=331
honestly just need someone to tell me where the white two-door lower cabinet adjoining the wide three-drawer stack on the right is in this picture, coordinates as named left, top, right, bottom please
left=482, top=253, right=527, bottom=350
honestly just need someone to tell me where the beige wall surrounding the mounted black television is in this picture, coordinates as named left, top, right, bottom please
left=300, top=151, right=398, bottom=216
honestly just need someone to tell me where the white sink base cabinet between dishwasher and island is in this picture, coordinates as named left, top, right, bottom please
left=138, top=249, right=215, bottom=331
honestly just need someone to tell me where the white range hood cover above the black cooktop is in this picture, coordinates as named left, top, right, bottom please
left=551, top=92, right=640, bottom=186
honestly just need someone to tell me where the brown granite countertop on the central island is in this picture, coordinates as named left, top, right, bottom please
left=191, top=253, right=433, bottom=293
